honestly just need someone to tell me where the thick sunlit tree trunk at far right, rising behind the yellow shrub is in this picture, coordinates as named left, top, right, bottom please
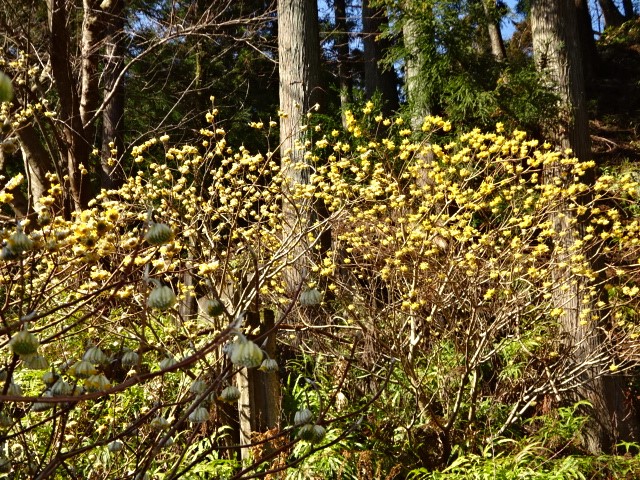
left=531, top=0, right=624, bottom=454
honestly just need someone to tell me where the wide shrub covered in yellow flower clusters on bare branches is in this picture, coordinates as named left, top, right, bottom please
left=0, top=99, right=640, bottom=478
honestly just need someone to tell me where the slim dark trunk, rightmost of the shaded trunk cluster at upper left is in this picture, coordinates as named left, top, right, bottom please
left=100, top=0, right=125, bottom=189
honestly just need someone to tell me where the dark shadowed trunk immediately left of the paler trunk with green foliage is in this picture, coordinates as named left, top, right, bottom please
left=362, top=0, right=400, bottom=115
